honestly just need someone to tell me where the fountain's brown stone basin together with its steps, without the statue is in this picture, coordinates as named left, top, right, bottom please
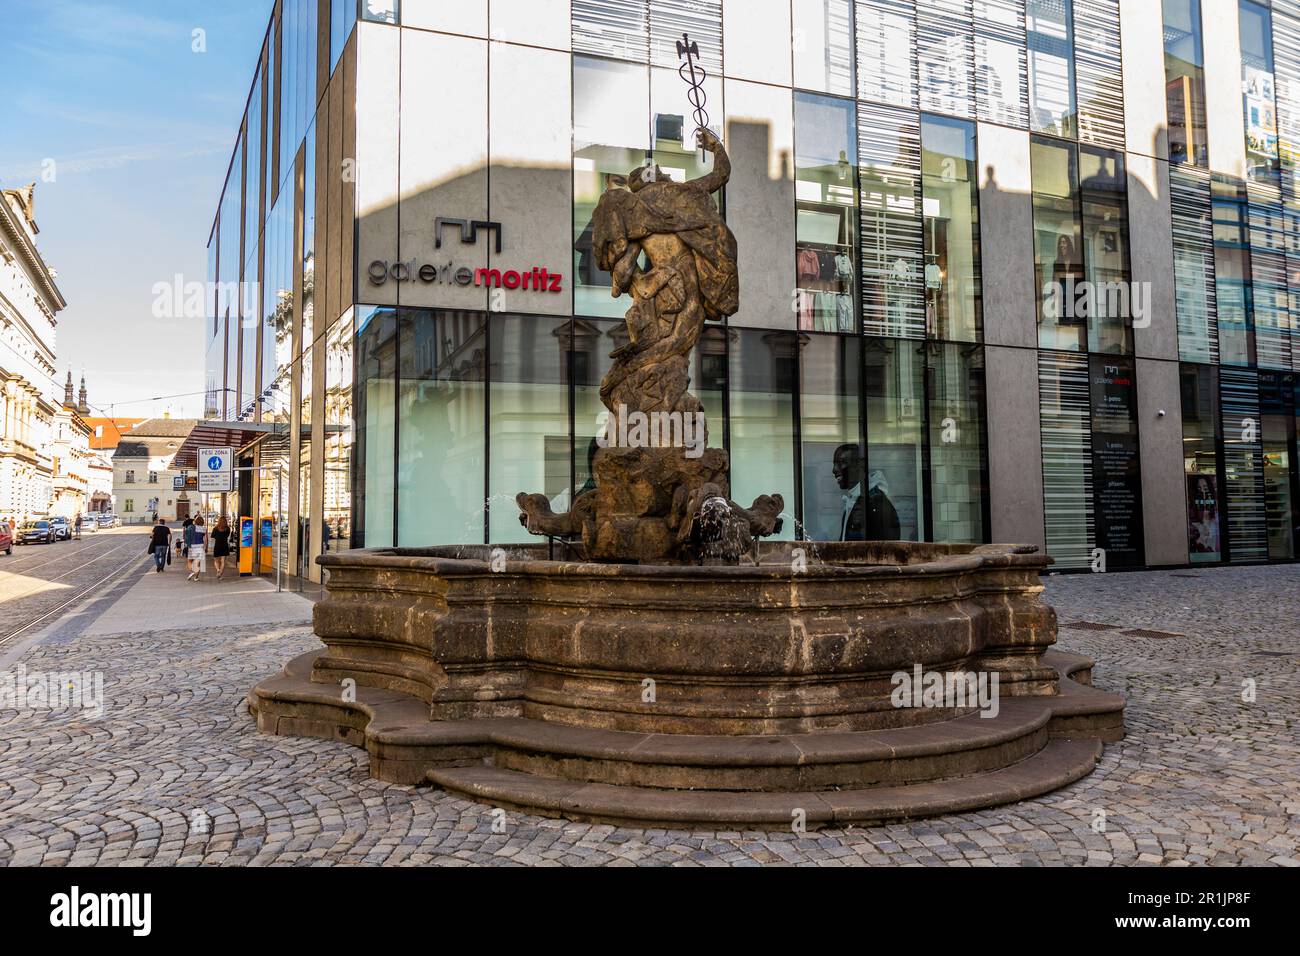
left=250, top=542, right=1123, bottom=826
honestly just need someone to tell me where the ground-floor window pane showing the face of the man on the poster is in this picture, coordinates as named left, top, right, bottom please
left=800, top=336, right=868, bottom=541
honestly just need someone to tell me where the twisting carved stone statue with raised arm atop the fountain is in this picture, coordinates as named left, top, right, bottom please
left=516, top=130, right=784, bottom=563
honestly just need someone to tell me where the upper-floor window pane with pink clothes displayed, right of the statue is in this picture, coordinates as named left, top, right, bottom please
left=794, top=94, right=858, bottom=332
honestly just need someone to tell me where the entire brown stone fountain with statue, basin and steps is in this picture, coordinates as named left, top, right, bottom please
left=250, top=131, right=1123, bottom=829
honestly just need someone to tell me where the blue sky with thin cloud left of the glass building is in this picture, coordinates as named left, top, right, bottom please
left=0, top=0, right=273, bottom=416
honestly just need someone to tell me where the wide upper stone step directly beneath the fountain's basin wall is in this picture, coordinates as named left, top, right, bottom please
left=250, top=654, right=1123, bottom=792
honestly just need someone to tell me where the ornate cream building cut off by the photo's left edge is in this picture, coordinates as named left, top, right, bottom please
left=0, top=183, right=66, bottom=518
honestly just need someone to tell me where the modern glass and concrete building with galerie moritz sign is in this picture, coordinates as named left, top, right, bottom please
left=191, top=0, right=1300, bottom=580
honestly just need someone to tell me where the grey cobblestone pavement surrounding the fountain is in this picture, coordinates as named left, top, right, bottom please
left=0, top=566, right=1300, bottom=866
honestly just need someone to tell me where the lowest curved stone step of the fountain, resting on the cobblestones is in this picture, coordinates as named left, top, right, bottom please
left=428, top=739, right=1101, bottom=830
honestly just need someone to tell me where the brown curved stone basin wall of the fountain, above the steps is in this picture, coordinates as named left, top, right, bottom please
left=315, top=542, right=1058, bottom=734
